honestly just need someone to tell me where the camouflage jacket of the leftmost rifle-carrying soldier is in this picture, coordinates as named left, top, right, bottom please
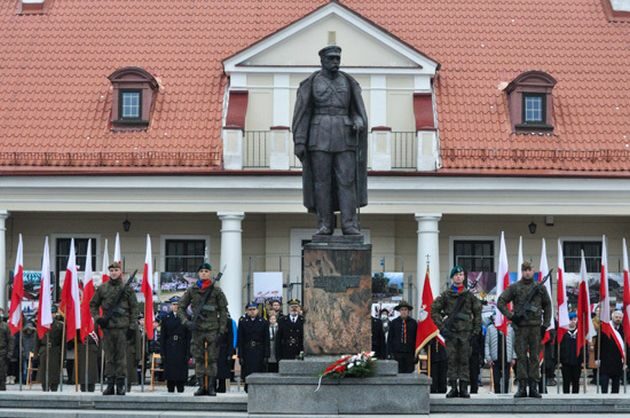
left=90, top=277, right=138, bottom=329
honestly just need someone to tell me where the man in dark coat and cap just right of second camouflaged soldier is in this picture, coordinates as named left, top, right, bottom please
left=237, top=302, right=269, bottom=392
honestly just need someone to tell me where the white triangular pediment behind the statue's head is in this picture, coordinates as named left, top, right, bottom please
left=224, top=3, right=438, bottom=74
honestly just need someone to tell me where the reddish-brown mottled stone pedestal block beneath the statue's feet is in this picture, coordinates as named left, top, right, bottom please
left=303, top=235, right=372, bottom=355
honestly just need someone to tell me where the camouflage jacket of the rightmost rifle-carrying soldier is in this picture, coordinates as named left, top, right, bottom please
left=497, top=279, right=551, bottom=328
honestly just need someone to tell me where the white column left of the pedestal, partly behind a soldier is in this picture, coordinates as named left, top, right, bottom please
left=217, top=212, right=245, bottom=321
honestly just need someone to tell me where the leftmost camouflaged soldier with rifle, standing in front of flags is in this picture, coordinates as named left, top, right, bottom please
left=90, top=262, right=138, bottom=395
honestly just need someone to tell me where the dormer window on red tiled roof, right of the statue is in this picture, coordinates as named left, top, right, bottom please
left=506, top=71, right=556, bottom=132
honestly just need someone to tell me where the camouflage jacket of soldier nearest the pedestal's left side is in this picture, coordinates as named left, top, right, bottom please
left=177, top=284, right=228, bottom=333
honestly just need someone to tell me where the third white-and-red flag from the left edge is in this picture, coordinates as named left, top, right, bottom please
left=59, top=238, right=81, bottom=341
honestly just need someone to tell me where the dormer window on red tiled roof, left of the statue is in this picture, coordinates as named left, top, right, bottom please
left=109, top=67, right=158, bottom=129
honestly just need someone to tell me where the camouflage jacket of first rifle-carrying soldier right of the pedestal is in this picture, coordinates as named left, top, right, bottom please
left=431, top=289, right=481, bottom=335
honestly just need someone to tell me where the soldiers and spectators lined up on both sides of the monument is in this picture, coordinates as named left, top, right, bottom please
left=0, top=262, right=627, bottom=398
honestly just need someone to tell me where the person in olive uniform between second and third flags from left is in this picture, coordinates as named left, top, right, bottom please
left=34, top=305, right=63, bottom=392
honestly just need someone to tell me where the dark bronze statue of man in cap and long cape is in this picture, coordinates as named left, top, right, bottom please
left=293, top=45, right=368, bottom=235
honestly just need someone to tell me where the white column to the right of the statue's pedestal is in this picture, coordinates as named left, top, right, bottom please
left=416, top=213, right=442, bottom=297
